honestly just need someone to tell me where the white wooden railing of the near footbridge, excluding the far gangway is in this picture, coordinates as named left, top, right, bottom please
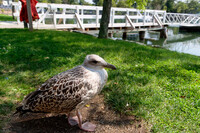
left=13, top=2, right=166, bottom=30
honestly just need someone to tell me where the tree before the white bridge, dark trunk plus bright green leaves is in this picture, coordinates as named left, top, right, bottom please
left=98, top=0, right=147, bottom=38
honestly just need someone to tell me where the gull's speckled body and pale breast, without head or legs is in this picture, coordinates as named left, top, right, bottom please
left=22, top=65, right=108, bottom=113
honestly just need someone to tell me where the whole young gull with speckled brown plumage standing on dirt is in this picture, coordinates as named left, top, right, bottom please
left=16, top=54, right=116, bottom=131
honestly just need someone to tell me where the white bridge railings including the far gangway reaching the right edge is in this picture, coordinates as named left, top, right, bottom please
left=10, top=2, right=200, bottom=30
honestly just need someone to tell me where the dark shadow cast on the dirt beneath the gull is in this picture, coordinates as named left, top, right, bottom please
left=9, top=115, right=81, bottom=133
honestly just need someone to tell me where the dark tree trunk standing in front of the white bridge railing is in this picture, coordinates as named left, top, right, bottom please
left=99, top=0, right=112, bottom=38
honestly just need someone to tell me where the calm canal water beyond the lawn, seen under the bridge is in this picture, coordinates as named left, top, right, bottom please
left=113, top=27, right=200, bottom=56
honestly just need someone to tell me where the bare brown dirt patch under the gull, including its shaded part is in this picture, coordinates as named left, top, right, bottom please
left=6, top=95, right=148, bottom=133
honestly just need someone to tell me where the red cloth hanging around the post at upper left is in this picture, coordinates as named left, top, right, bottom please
left=20, top=0, right=39, bottom=23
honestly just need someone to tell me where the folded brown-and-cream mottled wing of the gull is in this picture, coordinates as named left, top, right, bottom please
left=23, top=66, right=92, bottom=112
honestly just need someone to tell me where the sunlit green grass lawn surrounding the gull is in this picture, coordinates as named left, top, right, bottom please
left=0, top=29, right=200, bottom=133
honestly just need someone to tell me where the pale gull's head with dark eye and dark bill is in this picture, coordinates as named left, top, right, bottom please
left=83, top=54, right=116, bottom=70
